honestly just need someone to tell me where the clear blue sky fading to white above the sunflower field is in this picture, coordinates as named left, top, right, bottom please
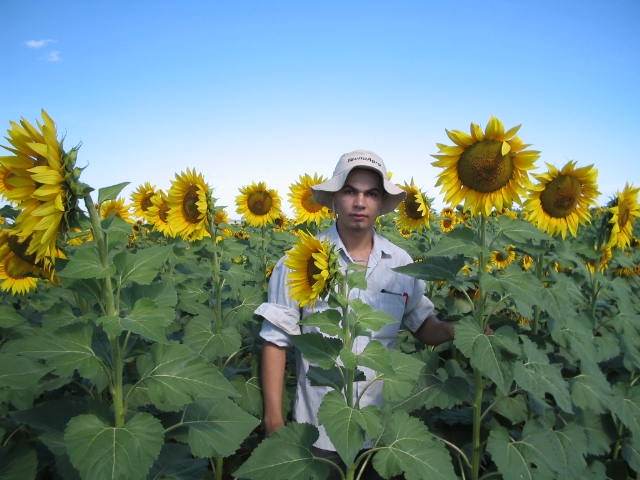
left=0, top=0, right=640, bottom=217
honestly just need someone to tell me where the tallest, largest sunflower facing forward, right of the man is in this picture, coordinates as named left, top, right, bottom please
left=432, top=116, right=540, bottom=216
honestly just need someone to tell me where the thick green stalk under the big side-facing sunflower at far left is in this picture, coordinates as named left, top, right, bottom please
left=84, top=194, right=126, bottom=428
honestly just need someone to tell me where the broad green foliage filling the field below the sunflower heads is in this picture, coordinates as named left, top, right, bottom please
left=0, top=185, right=640, bottom=480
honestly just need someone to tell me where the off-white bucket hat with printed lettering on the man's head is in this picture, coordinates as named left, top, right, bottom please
left=311, top=150, right=406, bottom=215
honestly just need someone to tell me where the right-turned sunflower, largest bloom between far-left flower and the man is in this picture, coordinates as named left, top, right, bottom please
left=167, top=169, right=213, bottom=241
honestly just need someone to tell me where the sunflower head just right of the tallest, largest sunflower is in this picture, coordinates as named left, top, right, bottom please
left=524, top=161, right=600, bottom=239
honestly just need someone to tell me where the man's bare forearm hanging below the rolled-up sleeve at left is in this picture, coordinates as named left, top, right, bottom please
left=262, top=342, right=287, bottom=435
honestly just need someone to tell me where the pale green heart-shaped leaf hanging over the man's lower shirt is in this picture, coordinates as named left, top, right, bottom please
left=318, top=390, right=366, bottom=466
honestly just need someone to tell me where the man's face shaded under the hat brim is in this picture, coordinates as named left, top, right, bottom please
left=333, top=168, right=385, bottom=232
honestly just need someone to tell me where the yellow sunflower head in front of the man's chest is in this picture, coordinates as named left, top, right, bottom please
left=285, top=232, right=338, bottom=307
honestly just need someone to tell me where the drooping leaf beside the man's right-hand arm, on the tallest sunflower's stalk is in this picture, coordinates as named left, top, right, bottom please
left=453, top=318, right=513, bottom=395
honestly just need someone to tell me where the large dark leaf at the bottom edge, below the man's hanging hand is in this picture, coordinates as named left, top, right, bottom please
left=233, top=423, right=329, bottom=480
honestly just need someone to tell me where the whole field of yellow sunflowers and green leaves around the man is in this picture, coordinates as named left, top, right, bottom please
left=0, top=110, right=640, bottom=480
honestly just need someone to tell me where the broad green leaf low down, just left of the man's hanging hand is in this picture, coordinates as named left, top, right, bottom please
left=182, top=398, right=260, bottom=458
